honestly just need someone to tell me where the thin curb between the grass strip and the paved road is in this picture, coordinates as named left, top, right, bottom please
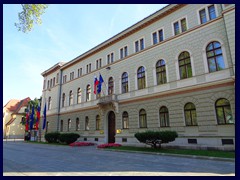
left=97, top=148, right=235, bottom=162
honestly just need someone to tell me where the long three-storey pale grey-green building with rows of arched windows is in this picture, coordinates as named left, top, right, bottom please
left=41, top=4, right=235, bottom=150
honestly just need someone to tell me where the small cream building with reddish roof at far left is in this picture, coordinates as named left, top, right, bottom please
left=3, top=97, right=31, bottom=139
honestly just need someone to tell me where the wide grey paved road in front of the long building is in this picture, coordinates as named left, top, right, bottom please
left=3, top=141, right=235, bottom=176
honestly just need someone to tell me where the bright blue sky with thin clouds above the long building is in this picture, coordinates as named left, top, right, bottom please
left=3, top=4, right=167, bottom=106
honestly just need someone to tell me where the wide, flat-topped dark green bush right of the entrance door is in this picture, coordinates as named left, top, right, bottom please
left=134, top=131, right=178, bottom=148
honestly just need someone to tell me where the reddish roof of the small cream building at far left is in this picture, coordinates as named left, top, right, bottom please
left=4, top=97, right=31, bottom=113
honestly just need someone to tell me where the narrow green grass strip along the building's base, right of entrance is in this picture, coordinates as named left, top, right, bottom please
left=109, top=146, right=235, bottom=158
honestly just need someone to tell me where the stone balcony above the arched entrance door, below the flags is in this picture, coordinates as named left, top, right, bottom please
left=97, top=94, right=118, bottom=113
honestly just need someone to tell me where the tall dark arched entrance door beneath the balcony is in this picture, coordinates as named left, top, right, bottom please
left=108, top=111, right=116, bottom=143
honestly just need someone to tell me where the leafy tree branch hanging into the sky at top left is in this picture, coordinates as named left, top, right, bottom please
left=15, top=4, right=48, bottom=33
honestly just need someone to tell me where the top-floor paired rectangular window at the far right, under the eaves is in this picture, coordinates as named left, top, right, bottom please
left=199, top=5, right=217, bottom=24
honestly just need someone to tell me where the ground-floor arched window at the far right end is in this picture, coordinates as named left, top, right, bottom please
left=215, top=98, right=233, bottom=124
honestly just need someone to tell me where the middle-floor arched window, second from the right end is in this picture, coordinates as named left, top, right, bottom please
left=178, top=51, right=192, bottom=79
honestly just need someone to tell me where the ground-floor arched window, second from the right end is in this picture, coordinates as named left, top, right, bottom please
left=184, top=103, right=197, bottom=126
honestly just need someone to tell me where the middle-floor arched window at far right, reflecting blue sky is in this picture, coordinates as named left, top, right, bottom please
left=206, top=41, right=225, bottom=72
